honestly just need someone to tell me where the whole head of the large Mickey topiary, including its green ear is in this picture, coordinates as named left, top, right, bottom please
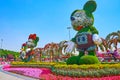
left=70, top=0, right=97, bottom=31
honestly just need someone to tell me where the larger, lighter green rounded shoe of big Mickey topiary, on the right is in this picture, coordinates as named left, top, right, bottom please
left=79, top=55, right=100, bottom=64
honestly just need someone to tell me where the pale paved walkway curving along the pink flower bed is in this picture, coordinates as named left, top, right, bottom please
left=0, top=65, right=39, bottom=80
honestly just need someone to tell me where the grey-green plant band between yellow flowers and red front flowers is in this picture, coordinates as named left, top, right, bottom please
left=53, top=68, right=120, bottom=77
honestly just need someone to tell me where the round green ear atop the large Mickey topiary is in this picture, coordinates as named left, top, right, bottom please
left=83, top=0, right=97, bottom=13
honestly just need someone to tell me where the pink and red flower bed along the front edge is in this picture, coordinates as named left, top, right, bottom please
left=4, top=68, right=120, bottom=80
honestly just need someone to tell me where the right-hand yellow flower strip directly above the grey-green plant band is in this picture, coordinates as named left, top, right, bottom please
left=54, top=63, right=120, bottom=70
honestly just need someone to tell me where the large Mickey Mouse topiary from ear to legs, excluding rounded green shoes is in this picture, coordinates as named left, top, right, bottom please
left=65, top=0, right=102, bottom=63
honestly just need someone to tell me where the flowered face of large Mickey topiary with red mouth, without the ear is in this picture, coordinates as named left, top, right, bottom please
left=71, top=10, right=94, bottom=31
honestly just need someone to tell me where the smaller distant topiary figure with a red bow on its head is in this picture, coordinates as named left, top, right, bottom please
left=20, top=34, right=39, bottom=62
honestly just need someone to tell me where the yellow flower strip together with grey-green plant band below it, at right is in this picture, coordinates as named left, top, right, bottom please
left=52, top=64, right=120, bottom=77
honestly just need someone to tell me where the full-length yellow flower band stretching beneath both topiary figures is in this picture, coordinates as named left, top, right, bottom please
left=11, top=62, right=120, bottom=70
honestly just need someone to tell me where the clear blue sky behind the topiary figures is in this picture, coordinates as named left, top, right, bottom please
left=0, top=0, right=120, bottom=51
